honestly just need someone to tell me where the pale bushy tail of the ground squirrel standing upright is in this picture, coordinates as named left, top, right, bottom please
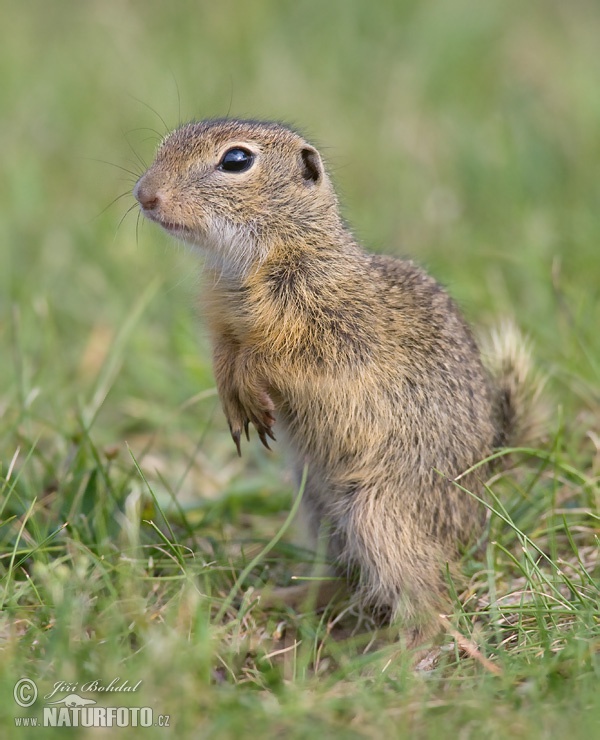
left=482, top=320, right=549, bottom=447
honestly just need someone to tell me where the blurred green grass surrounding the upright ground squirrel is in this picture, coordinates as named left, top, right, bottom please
left=0, top=0, right=600, bottom=738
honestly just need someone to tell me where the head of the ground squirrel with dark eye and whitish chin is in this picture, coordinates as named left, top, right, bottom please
left=134, top=120, right=338, bottom=274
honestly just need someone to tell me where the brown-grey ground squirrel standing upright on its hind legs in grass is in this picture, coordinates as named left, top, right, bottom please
left=134, top=119, right=544, bottom=642
